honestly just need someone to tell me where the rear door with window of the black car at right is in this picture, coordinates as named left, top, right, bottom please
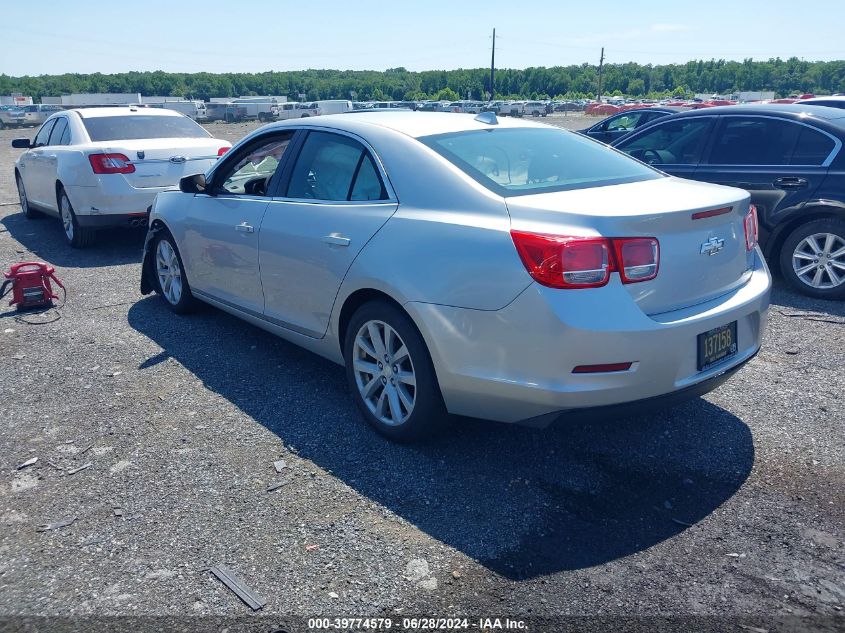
left=695, top=115, right=836, bottom=227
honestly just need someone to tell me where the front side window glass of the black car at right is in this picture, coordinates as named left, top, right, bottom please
left=617, top=117, right=711, bottom=165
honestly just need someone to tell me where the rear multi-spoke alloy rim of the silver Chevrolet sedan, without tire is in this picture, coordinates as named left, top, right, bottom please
left=352, top=320, right=417, bottom=426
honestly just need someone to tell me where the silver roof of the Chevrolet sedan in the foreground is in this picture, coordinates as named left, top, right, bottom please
left=271, top=109, right=557, bottom=138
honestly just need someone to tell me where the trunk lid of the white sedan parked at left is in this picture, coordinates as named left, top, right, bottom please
left=91, top=138, right=230, bottom=189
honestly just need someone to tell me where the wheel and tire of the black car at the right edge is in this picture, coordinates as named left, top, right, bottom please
left=780, top=218, right=845, bottom=299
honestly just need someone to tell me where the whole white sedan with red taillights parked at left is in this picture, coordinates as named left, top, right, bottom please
left=12, top=107, right=231, bottom=248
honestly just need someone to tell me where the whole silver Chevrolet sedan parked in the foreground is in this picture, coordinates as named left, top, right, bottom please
left=141, top=111, right=771, bottom=440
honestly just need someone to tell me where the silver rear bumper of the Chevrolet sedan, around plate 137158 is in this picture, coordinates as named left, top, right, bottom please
left=406, top=250, right=771, bottom=426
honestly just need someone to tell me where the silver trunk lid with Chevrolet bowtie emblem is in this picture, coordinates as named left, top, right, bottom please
left=507, top=178, right=754, bottom=315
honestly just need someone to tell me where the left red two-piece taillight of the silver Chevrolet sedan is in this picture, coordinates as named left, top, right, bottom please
left=511, top=231, right=660, bottom=288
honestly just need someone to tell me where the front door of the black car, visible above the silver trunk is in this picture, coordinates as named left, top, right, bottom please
left=613, top=115, right=716, bottom=178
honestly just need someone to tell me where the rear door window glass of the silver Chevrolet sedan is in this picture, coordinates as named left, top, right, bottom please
left=287, top=132, right=387, bottom=201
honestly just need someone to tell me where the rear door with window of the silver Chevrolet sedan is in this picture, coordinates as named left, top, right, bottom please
left=260, top=131, right=397, bottom=337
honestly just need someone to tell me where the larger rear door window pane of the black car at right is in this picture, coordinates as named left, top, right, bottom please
left=709, top=117, right=802, bottom=165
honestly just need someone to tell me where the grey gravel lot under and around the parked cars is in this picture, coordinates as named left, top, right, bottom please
left=0, top=116, right=845, bottom=631
